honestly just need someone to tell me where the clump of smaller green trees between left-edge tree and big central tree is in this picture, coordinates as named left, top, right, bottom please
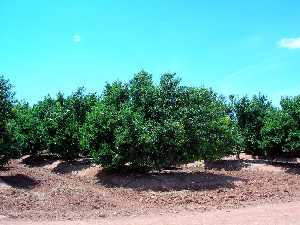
left=9, top=88, right=97, bottom=159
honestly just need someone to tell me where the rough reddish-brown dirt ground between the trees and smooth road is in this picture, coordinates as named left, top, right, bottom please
left=0, top=155, right=300, bottom=221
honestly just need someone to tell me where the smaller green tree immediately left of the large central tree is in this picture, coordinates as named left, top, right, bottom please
left=41, top=88, right=97, bottom=160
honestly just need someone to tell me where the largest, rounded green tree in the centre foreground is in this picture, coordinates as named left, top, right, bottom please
left=82, top=71, right=236, bottom=169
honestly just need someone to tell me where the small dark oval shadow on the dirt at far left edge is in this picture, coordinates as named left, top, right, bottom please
left=0, top=174, right=40, bottom=189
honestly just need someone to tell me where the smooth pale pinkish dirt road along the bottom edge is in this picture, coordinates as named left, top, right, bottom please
left=0, top=202, right=300, bottom=225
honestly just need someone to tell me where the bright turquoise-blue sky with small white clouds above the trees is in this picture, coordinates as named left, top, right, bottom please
left=0, top=0, right=300, bottom=104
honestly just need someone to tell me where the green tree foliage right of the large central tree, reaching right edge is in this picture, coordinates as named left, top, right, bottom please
left=231, top=95, right=300, bottom=157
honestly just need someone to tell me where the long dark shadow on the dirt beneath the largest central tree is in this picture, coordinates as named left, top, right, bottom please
left=97, top=171, right=244, bottom=191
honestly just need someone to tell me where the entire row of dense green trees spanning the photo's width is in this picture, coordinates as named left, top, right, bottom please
left=0, top=71, right=300, bottom=170
